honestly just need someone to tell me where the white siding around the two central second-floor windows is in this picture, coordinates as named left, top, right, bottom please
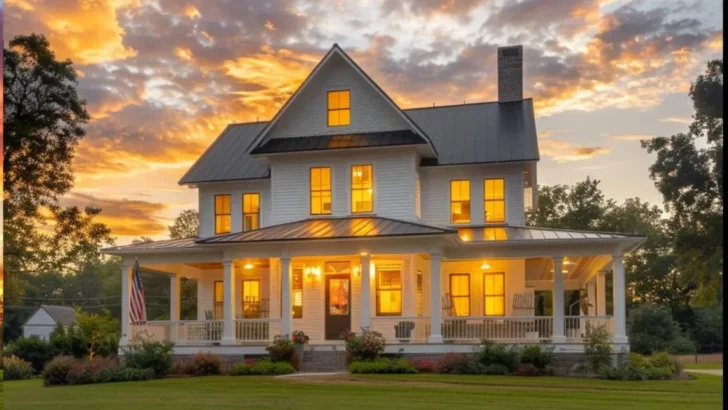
left=271, top=148, right=418, bottom=224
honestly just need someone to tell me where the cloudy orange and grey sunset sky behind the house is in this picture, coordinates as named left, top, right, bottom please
left=2, top=0, right=723, bottom=244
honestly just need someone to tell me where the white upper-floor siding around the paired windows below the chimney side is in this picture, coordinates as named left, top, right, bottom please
left=420, top=164, right=525, bottom=225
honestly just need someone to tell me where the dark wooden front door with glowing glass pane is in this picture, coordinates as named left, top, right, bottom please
left=324, top=274, right=351, bottom=340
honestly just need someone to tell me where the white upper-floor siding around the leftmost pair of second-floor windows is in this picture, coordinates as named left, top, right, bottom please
left=199, top=179, right=272, bottom=238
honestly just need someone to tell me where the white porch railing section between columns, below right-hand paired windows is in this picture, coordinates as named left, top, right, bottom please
left=442, top=316, right=553, bottom=342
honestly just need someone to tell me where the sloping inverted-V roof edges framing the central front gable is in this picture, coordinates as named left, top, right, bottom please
left=248, top=43, right=437, bottom=156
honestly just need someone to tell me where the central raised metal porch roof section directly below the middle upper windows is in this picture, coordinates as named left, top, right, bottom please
left=197, top=217, right=457, bottom=244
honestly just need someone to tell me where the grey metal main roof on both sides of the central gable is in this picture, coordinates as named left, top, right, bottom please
left=179, top=99, right=539, bottom=184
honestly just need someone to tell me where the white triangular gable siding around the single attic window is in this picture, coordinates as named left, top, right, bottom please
left=267, top=55, right=409, bottom=138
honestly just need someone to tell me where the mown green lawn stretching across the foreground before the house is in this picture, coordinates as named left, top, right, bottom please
left=3, top=374, right=722, bottom=410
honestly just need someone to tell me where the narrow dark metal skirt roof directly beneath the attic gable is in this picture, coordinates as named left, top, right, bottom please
left=250, top=130, right=427, bottom=155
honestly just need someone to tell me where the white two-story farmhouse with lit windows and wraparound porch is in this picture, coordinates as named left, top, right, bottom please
left=105, top=45, right=645, bottom=354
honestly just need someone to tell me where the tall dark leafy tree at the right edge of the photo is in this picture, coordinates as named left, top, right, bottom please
left=642, top=60, right=723, bottom=306
